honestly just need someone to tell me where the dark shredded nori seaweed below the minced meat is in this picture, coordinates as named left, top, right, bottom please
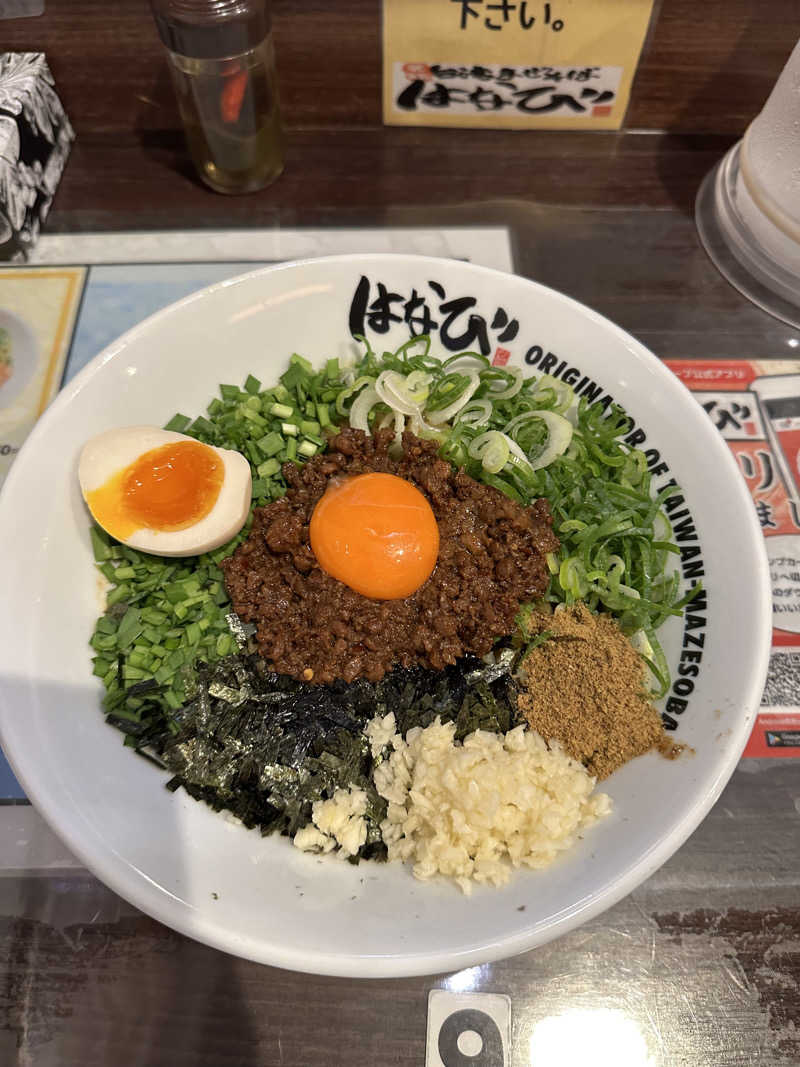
left=107, top=648, right=517, bottom=861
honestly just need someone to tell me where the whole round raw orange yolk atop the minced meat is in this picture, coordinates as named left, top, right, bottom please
left=309, top=473, right=438, bottom=600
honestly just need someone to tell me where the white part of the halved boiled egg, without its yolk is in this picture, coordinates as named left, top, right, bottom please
left=78, top=426, right=252, bottom=556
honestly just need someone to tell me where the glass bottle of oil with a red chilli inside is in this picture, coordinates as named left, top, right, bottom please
left=151, top=0, right=284, bottom=193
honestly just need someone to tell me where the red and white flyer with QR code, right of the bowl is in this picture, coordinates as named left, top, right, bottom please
left=668, top=360, right=800, bottom=757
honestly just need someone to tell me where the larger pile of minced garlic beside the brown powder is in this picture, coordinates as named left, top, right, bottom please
left=373, top=716, right=611, bottom=893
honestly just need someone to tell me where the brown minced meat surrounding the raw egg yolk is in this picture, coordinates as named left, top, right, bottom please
left=222, top=429, right=558, bottom=684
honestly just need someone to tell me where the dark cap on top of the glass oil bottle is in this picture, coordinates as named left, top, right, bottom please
left=150, top=0, right=270, bottom=60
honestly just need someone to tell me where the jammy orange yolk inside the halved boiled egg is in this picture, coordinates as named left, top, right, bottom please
left=86, top=441, right=225, bottom=541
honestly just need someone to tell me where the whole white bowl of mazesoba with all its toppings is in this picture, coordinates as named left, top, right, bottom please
left=0, top=255, right=770, bottom=976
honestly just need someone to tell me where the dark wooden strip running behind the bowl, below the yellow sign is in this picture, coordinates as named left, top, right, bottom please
left=40, top=128, right=746, bottom=232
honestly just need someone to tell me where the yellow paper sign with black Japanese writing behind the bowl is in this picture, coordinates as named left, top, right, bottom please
left=383, top=0, right=653, bottom=129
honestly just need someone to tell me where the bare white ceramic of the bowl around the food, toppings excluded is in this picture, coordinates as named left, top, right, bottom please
left=0, top=255, right=770, bottom=976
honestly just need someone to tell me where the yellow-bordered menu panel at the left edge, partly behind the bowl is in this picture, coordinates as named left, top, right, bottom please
left=0, top=267, right=85, bottom=485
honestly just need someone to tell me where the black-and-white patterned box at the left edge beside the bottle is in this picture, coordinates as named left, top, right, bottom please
left=0, top=52, right=75, bottom=261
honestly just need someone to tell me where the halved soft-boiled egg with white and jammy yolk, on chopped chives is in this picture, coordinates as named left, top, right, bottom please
left=78, top=426, right=251, bottom=556
